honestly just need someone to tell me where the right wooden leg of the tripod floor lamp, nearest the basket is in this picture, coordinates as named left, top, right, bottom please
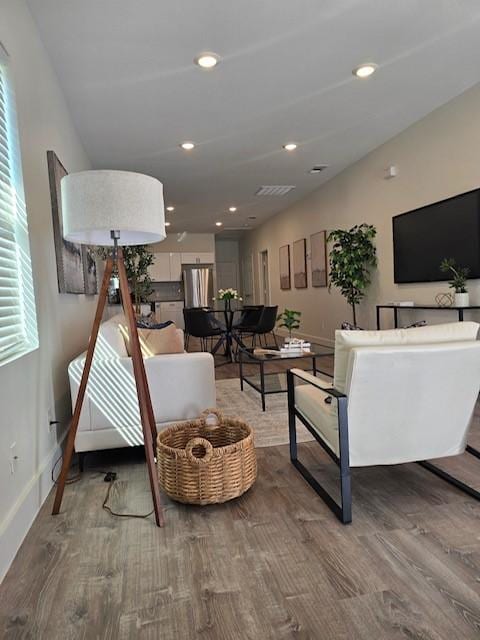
left=117, top=249, right=164, bottom=527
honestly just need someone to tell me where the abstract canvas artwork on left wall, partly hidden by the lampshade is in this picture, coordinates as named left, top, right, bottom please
left=47, top=151, right=97, bottom=294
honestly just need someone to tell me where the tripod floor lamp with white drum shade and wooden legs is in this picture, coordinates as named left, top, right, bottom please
left=52, top=171, right=165, bottom=527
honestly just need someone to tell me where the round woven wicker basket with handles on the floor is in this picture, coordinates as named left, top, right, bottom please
left=157, top=409, right=257, bottom=505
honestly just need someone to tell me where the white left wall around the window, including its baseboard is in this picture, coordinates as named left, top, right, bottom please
left=0, top=0, right=96, bottom=579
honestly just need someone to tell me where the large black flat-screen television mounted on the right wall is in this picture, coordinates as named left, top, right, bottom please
left=393, top=189, right=480, bottom=283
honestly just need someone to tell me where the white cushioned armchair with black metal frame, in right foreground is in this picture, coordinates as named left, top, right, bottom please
left=288, top=322, right=480, bottom=524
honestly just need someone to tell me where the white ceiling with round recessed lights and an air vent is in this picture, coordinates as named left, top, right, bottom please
left=28, top=0, right=480, bottom=232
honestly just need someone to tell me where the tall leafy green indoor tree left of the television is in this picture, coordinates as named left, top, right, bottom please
left=327, top=223, right=377, bottom=325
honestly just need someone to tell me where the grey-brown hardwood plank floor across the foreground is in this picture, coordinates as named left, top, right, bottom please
left=0, top=344, right=480, bottom=640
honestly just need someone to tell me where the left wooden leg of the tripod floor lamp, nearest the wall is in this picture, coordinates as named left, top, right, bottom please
left=52, top=258, right=113, bottom=515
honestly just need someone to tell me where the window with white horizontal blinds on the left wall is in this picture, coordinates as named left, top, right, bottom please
left=0, top=45, right=38, bottom=365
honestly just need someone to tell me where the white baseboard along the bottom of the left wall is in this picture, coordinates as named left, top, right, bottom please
left=0, top=431, right=67, bottom=583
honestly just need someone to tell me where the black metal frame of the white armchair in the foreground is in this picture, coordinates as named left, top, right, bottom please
left=287, top=370, right=480, bottom=524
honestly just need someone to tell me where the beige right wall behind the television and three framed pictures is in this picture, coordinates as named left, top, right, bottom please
left=241, top=85, right=480, bottom=341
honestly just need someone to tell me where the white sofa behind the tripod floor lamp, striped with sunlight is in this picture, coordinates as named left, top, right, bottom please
left=68, top=315, right=216, bottom=453
